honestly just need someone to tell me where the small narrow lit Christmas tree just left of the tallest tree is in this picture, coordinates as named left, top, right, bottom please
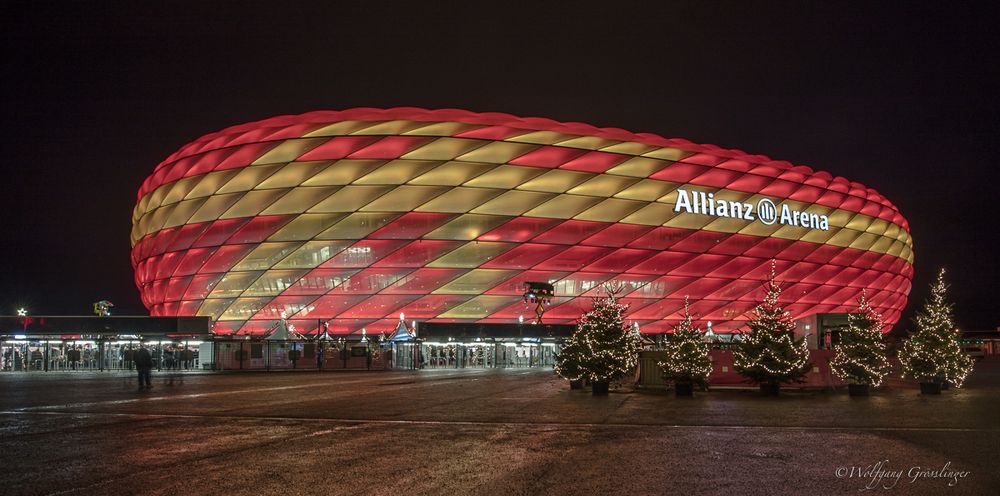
left=659, top=296, right=712, bottom=395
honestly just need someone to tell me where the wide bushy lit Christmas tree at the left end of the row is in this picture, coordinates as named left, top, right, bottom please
left=556, top=286, right=642, bottom=394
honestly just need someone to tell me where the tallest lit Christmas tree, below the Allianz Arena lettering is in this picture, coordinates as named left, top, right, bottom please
left=733, top=261, right=811, bottom=394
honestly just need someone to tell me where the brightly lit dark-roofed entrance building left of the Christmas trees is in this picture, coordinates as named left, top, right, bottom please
left=415, top=322, right=576, bottom=369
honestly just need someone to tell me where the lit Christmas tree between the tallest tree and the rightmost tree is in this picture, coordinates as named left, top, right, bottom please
left=830, top=293, right=889, bottom=387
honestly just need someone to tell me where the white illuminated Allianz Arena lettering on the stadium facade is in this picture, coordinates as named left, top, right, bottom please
left=674, top=188, right=830, bottom=231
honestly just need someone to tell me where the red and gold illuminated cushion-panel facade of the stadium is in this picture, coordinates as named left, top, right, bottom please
left=131, top=108, right=913, bottom=334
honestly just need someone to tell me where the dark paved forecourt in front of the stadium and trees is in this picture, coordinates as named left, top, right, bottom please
left=0, top=360, right=1000, bottom=495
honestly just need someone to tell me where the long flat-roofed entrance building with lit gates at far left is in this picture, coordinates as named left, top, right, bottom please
left=0, top=315, right=210, bottom=372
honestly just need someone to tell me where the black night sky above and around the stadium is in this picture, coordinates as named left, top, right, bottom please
left=0, top=1, right=1000, bottom=328
